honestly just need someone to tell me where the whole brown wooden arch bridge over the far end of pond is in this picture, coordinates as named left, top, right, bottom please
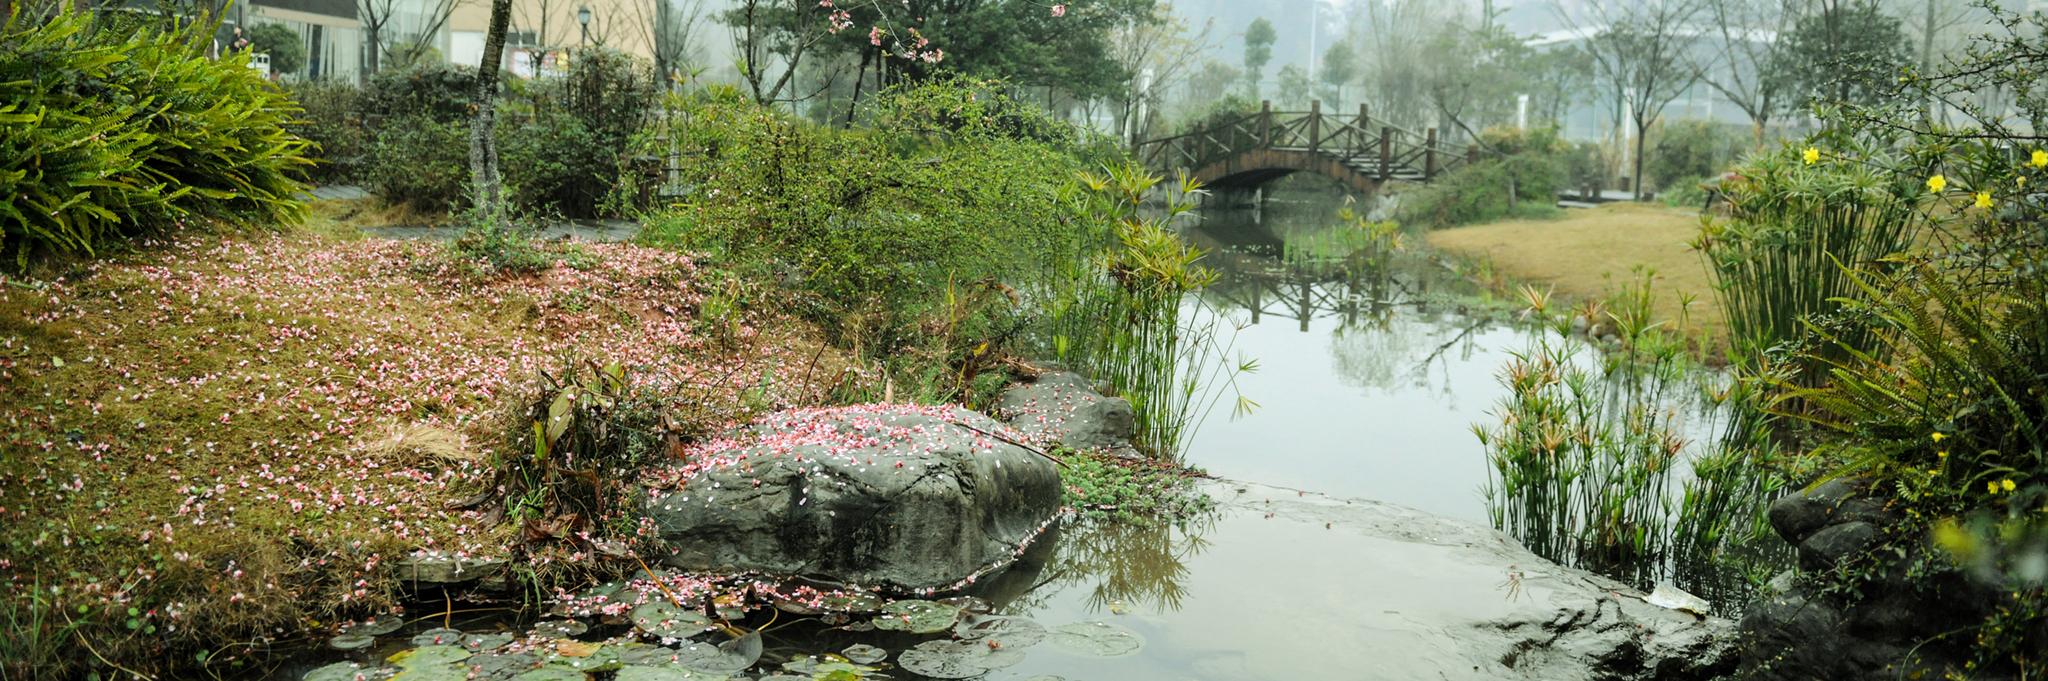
left=1137, top=102, right=1479, bottom=194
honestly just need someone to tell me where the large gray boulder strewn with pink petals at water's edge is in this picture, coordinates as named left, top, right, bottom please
left=643, top=405, right=1061, bottom=589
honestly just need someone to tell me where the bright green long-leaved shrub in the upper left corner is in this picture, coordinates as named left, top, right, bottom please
left=0, top=8, right=311, bottom=266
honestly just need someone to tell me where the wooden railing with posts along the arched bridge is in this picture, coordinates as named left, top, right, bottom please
left=1135, top=102, right=1481, bottom=180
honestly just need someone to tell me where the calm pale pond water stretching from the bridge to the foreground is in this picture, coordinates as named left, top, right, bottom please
left=270, top=191, right=1744, bottom=681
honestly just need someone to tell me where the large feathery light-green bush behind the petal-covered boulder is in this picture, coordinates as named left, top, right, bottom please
left=645, top=88, right=1085, bottom=354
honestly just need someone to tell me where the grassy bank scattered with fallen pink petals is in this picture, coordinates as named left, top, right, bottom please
left=0, top=209, right=848, bottom=679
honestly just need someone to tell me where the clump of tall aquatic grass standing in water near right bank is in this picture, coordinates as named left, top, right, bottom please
left=1473, top=272, right=1786, bottom=603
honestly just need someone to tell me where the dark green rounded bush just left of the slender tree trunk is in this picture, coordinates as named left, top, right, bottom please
left=362, top=115, right=469, bottom=213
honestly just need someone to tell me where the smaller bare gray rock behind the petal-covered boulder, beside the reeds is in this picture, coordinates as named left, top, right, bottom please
left=995, top=372, right=1137, bottom=450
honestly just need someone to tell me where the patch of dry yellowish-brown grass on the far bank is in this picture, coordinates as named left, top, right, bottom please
left=1430, top=202, right=1729, bottom=344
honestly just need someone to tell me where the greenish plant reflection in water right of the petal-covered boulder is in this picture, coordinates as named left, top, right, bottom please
left=1004, top=513, right=1214, bottom=614
